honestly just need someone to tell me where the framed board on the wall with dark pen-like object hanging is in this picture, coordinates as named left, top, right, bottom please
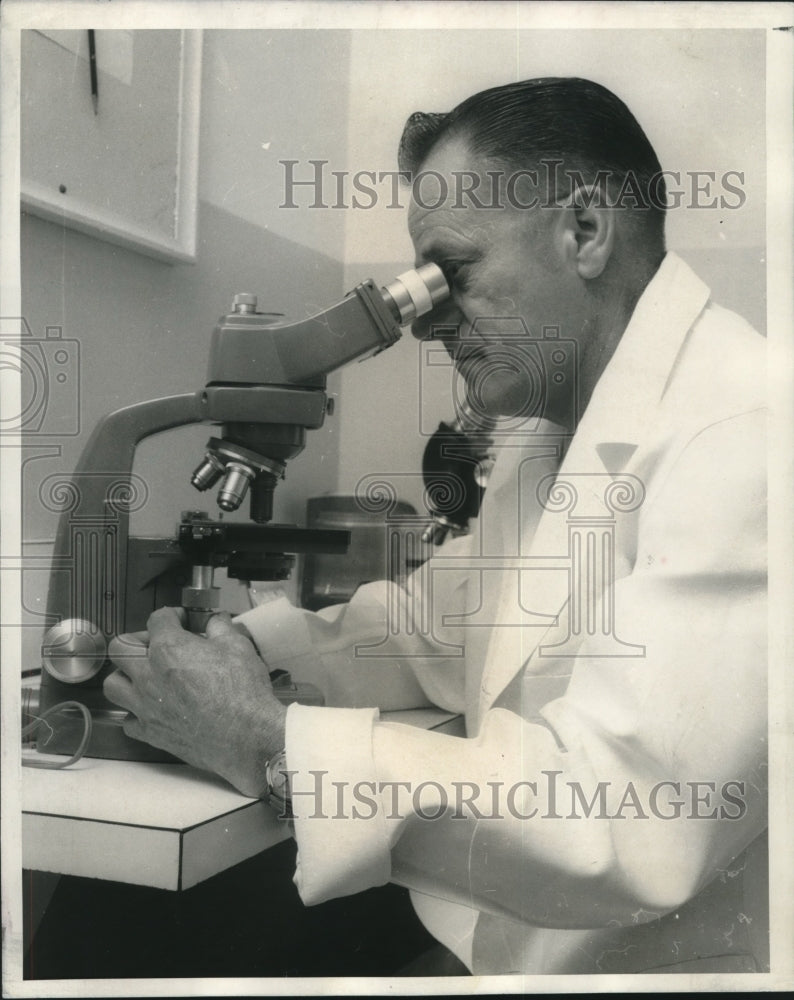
left=20, top=29, right=202, bottom=263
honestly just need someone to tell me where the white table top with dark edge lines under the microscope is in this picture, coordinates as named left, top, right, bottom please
left=22, top=758, right=290, bottom=889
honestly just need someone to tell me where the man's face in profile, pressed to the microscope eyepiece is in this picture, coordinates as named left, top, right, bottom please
left=408, top=140, right=586, bottom=422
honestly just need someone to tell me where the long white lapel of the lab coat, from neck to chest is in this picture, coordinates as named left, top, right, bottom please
left=478, top=253, right=710, bottom=719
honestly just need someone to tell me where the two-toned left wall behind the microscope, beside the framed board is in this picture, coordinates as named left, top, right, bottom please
left=22, top=31, right=349, bottom=667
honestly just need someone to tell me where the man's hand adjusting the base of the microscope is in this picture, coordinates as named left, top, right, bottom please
left=104, top=608, right=286, bottom=796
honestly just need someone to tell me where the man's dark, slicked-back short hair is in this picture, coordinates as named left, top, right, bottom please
left=398, top=77, right=667, bottom=246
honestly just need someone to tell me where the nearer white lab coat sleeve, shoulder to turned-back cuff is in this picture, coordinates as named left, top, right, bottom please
left=287, top=413, right=766, bottom=928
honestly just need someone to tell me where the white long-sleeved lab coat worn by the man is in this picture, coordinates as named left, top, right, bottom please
left=242, top=254, right=767, bottom=974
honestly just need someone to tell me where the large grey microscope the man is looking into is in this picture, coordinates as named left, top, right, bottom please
left=28, top=264, right=449, bottom=761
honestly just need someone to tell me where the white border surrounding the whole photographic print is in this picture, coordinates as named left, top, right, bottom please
left=0, top=0, right=794, bottom=997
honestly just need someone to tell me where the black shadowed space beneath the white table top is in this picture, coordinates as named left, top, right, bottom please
left=23, top=840, right=436, bottom=980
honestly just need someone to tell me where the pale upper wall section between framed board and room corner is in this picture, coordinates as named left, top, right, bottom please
left=199, top=29, right=351, bottom=256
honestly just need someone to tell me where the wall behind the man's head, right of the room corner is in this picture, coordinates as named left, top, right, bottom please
left=326, top=30, right=766, bottom=505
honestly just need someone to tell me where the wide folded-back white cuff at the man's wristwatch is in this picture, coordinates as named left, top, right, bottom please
left=286, top=704, right=391, bottom=906
